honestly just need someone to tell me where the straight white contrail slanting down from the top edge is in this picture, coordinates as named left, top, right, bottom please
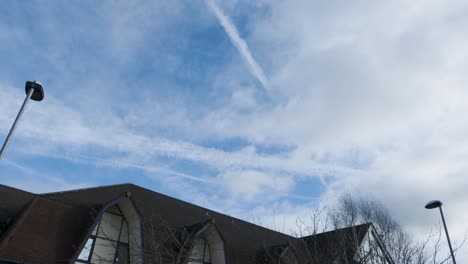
left=205, top=0, right=268, bottom=89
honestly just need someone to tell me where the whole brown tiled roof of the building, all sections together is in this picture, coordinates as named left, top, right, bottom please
left=0, top=184, right=384, bottom=264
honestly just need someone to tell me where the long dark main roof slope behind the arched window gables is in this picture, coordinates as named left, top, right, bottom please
left=45, top=184, right=295, bottom=264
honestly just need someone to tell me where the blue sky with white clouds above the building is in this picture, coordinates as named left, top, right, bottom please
left=0, top=0, right=468, bottom=261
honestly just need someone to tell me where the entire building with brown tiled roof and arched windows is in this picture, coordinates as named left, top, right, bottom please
left=0, top=184, right=393, bottom=264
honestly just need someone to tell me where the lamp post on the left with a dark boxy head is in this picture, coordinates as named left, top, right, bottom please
left=0, top=81, right=44, bottom=160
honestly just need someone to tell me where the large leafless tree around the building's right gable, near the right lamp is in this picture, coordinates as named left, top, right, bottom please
left=288, top=194, right=466, bottom=264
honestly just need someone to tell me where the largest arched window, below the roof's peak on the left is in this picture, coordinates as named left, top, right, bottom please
left=77, top=205, right=130, bottom=264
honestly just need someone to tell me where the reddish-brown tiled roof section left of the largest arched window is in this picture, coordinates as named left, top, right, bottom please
left=0, top=196, right=91, bottom=264
